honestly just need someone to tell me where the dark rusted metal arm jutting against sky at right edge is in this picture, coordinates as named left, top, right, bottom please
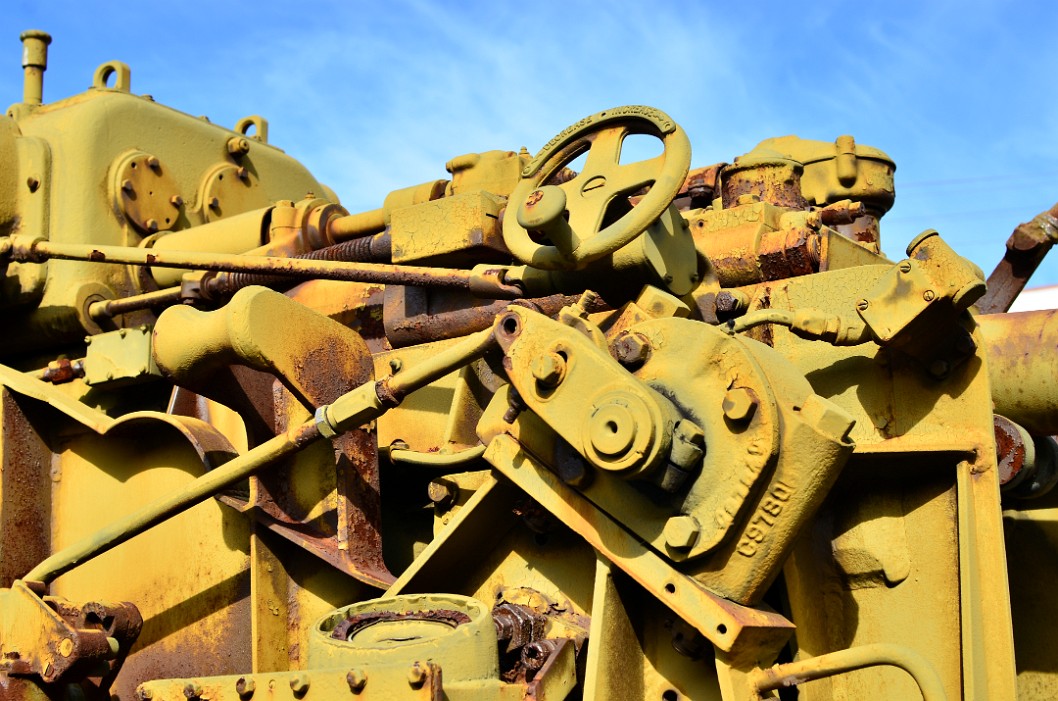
left=977, top=204, right=1058, bottom=314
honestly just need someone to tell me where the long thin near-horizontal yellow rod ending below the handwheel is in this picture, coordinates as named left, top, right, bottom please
left=8, top=236, right=472, bottom=290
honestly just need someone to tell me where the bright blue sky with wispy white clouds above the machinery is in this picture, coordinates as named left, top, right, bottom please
left=0, top=0, right=1058, bottom=284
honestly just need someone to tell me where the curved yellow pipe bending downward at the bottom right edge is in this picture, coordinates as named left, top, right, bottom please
left=753, top=643, right=948, bottom=701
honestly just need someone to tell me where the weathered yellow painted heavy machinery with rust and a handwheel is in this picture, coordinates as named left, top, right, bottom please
left=0, top=32, right=1058, bottom=701
